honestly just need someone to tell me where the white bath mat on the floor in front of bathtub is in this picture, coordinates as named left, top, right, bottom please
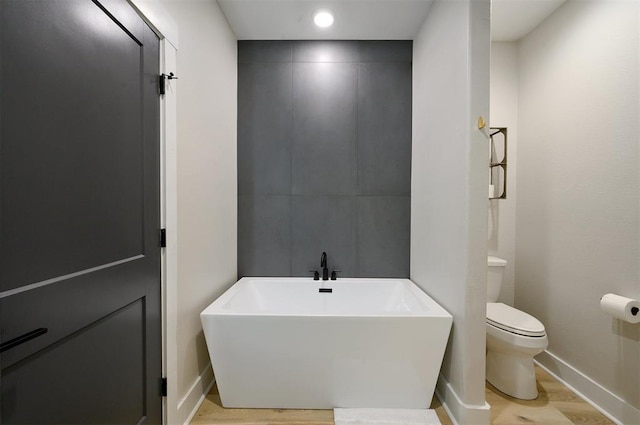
left=333, top=409, right=441, bottom=425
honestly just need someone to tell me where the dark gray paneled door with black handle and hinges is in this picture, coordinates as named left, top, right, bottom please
left=0, top=0, right=162, bottom=425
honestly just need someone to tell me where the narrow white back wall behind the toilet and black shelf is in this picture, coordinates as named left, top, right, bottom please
left=488, top=41, right=518, bottom=305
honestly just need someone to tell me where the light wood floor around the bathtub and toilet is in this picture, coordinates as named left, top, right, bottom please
left=191, top=367, right=613, bottom=425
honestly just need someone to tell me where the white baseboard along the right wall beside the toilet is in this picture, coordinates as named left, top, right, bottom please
left=535, top=351, right=640, bottom=425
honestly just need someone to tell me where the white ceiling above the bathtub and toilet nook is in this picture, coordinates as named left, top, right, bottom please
left=218, top=0, right=565, bottom=41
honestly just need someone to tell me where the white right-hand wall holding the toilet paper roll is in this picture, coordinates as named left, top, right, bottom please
left=515, top=0, right=640, bottom=424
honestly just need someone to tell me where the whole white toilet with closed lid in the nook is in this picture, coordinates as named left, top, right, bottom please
left=487, top=256, right=549, bottom=400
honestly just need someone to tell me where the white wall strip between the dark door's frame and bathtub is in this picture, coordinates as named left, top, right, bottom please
left=156, top=0, right=237, bottom=423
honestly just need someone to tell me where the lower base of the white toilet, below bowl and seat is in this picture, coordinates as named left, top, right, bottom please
left=487, top=350, right=538, bottom=400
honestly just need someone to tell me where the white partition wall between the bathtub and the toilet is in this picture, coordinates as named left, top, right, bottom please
left=411, top=0, right=490, bottom=424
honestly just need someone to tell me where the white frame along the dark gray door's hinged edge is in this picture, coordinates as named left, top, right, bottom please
left=127, top=0, right=181, bottom=425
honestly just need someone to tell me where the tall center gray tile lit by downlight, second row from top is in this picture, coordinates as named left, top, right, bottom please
left=291, top=63, right=358, bottom=196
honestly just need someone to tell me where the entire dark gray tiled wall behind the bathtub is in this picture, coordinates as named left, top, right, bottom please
left=238, top=41, right=412, bottom=277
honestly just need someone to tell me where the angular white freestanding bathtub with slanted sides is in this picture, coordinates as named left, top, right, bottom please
left=200, top=278, right=452, bottom=409
